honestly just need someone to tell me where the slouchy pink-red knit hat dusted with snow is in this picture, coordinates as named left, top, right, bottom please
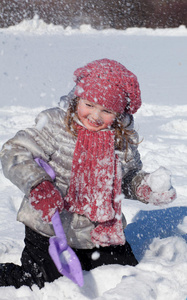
left=74, top=58, right=141, bottom=114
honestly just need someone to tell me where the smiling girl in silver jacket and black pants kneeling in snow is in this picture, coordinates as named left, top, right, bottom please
left=0, top=59, right=176, bottom=288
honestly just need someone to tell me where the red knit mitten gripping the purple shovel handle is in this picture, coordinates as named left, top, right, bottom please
left=30, top=181, right=64, bottom=222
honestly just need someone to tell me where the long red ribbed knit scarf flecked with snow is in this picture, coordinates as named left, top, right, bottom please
left=64, top=127, right=125, bottom=246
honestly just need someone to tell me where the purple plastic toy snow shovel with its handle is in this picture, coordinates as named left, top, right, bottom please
left=35, top=158, right=84, bottom=287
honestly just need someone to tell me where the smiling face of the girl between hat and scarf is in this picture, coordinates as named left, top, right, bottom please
left=77, top=99, right=116, bottom=131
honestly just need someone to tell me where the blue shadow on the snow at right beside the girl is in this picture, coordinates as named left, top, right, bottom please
left=125, top=206, right=187, bottom=261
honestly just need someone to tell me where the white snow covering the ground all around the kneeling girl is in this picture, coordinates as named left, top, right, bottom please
left=0, top=18, right=187, bottom=300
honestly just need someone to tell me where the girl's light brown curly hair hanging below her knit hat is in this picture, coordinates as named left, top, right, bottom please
left=65, top=97, right=135, bottom=160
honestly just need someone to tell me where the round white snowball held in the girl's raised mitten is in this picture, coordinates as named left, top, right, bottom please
left=147, top=167, right=171, bottom=193
